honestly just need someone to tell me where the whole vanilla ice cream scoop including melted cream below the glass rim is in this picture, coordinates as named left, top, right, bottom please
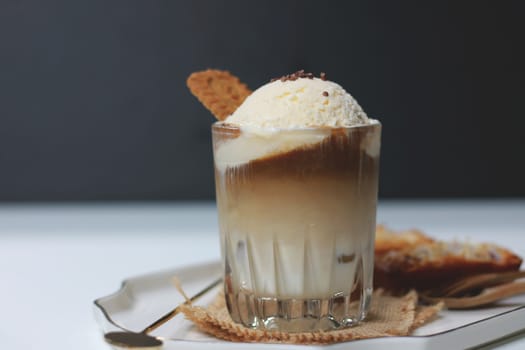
left=215, top=71, right=379, bottom=171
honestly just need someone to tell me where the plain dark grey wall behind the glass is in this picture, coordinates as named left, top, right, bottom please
left=0, top=0, right=525, bottom=201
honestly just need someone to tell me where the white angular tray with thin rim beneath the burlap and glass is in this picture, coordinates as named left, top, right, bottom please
left=94, top=262, right=525, bottom=350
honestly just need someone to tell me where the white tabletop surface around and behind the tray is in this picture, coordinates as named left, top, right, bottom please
left=0, top=200, right=525, bottom=350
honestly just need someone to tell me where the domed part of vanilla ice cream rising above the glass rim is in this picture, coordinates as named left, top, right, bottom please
left=225, top=78, right=371, bottom=129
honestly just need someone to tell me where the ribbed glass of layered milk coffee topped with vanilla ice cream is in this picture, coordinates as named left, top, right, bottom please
left=212, top=72, right=381, bottom=332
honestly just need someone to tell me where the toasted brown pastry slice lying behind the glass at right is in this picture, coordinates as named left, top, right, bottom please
left=374, top=226, right=522, bottom=291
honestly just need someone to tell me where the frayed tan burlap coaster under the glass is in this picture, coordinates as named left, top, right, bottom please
left=181, top=290, right=443, bottom=344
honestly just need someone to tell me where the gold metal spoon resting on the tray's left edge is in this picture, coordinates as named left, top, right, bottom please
left=104, top=278, right=222, bottom=348
